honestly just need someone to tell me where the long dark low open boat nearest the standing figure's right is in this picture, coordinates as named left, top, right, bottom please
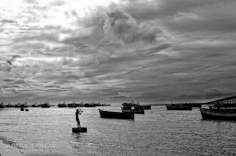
left=99, top=109, right=134, bottom=119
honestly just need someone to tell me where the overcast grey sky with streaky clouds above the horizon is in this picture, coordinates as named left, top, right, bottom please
left=0, top=0, right=236, bottom=103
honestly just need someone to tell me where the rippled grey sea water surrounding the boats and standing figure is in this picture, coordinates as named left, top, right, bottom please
left=0, top=106, right=236, bottom=156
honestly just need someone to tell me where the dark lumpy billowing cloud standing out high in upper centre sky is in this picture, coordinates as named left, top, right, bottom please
left=103, top=9, right=166, bottom=44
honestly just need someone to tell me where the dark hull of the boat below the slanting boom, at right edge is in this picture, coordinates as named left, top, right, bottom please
left=200, top=108, right=236, bottom=120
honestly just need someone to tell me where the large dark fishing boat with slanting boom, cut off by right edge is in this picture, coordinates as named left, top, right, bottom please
left=200, top=96, right=236, bottom=120
